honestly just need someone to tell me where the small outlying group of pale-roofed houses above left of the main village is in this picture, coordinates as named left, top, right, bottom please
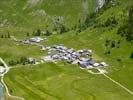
left=23, top=37, right=46, bottom=44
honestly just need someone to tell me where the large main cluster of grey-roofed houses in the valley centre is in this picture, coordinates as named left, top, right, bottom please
left=41, top=45, right=108, bottom=69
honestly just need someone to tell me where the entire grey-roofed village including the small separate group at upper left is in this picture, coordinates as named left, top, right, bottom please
left=11, top=37, right=109, bottom=69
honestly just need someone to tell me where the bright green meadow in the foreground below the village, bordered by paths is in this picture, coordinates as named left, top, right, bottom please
left=5, top=63, right=132, bottom=100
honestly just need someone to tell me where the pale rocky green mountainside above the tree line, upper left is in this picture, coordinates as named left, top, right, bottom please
left=0, top=0, right=96, bottom=29
